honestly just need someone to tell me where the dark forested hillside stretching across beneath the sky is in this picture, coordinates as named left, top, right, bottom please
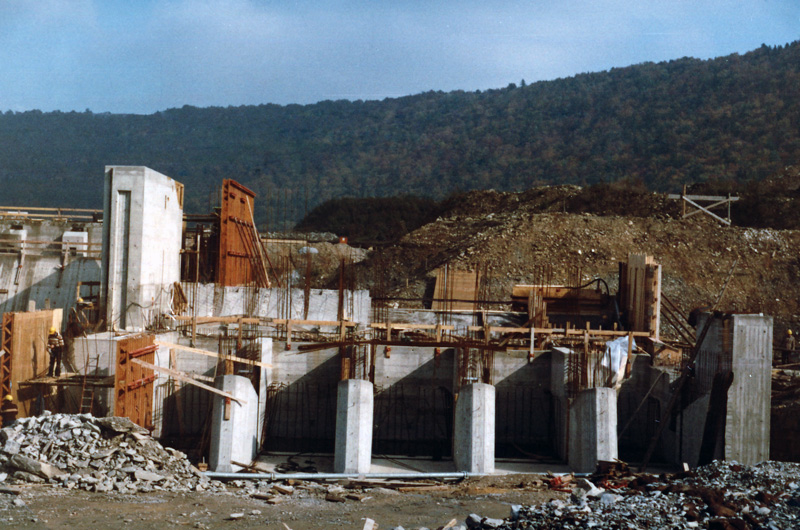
left=0, top=38, right=800, bottom=228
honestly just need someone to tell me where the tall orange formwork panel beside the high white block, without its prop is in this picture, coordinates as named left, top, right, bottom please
left=217, top=179, right=256, bottom=285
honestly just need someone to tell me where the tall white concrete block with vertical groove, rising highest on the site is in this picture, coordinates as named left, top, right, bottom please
left=101, top=166, right=183, bottom=330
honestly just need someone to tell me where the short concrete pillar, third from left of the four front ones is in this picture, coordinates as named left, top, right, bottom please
left=454, top=383, right=495, bottom=473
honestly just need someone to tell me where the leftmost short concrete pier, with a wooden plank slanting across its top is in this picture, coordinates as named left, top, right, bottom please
left=208, top=375, right=258, bottom=473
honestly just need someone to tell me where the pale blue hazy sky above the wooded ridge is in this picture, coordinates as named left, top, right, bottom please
left=0, top=0, right=800, bottom=114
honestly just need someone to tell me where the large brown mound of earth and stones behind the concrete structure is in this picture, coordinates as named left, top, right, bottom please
left=361, top=186, right=800, bottom=336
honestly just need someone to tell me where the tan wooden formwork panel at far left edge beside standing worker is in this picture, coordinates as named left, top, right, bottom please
left=0, top=309, right=63, bottom=418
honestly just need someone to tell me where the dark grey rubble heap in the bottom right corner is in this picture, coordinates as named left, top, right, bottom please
left=466, top=461, right=800, bottom=530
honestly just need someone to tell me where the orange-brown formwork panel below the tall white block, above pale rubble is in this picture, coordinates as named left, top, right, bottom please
left=114, top=334, right=157, bottom=430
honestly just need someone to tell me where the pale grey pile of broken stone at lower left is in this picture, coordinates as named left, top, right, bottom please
left=0, top=412, right=224, bottom=493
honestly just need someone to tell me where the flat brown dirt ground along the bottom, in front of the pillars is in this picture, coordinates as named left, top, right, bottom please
left=0, top=475, right=566, bottom=530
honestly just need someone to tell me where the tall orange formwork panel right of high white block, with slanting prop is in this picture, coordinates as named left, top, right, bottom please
left=217, top=179, right=269, bottom=287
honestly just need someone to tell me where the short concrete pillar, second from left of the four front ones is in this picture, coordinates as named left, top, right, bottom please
left=333, top=379, right=374, bottom=473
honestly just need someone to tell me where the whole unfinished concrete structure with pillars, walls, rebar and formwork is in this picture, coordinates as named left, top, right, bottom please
left=0, top=166, right=772, bottom=474
